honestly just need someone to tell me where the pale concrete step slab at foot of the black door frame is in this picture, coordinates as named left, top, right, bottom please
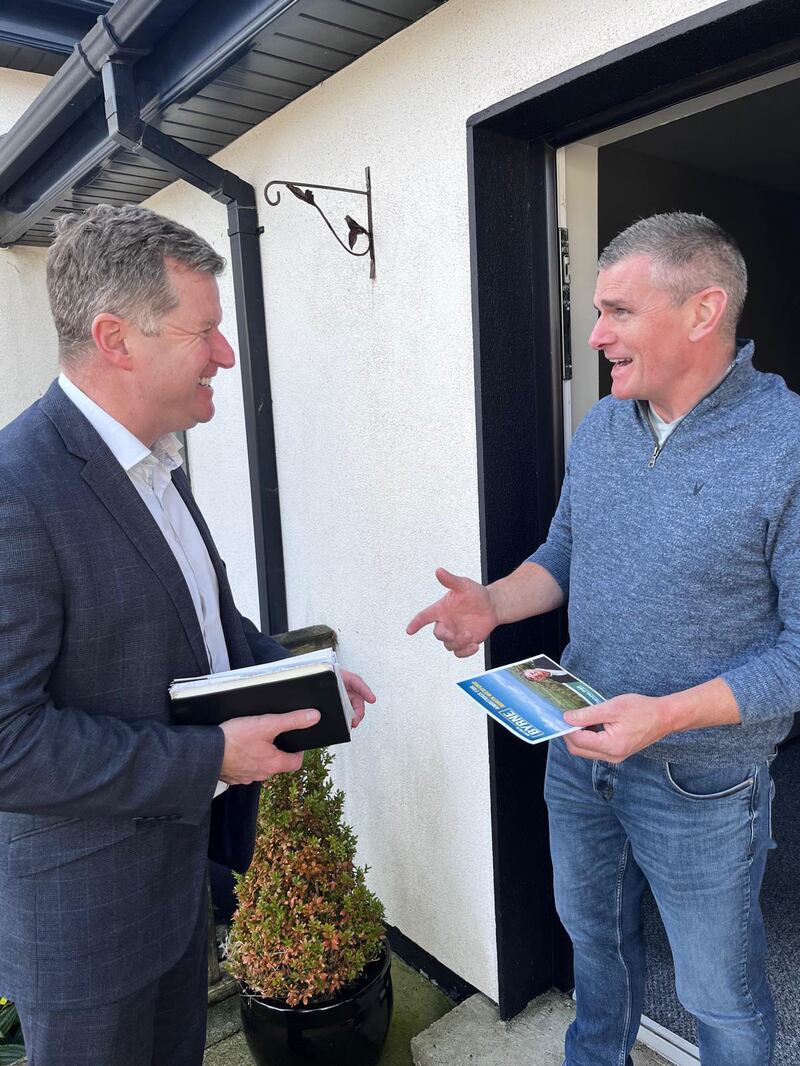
left=411, top=991, right=667, bottom=1066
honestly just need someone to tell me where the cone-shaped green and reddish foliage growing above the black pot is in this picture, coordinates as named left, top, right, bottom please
left=228, top=749, right=383, bottom=1006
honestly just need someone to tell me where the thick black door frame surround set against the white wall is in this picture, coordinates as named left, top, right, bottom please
left=467, top=0, right=800, bottom=1018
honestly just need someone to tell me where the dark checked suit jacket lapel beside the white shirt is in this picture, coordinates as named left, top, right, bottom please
left=39, top=382, right=210, bottom=674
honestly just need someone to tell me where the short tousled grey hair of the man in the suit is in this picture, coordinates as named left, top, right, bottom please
left=47, top=204, right=225, bottom=367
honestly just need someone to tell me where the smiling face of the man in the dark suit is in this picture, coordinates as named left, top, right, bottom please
left=125, top=259, right=236, bottom=447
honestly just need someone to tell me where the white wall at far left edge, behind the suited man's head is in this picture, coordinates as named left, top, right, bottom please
left=0, top=67, right=58, bottom=426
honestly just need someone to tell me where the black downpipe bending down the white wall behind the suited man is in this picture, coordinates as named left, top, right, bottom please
left=102, top=61, right=288, bottom=633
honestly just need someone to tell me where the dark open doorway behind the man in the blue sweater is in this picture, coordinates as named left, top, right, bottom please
left=558, top=67, right=800, bottom=1066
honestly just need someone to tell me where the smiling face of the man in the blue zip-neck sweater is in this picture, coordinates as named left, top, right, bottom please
left=589, top=256, right=695, bottom=421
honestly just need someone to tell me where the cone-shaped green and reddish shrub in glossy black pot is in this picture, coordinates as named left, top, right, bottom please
left=227, top=749, right=393, bottom=1066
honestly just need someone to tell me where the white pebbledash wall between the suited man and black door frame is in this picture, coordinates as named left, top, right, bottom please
left=0, top=0, right=725, bottom=998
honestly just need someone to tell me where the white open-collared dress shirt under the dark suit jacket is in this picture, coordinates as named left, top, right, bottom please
left=59, top=373, right=230, bottom=795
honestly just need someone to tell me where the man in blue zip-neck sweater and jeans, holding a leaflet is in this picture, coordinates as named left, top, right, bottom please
left=409, top=213, right=800, bottom=1066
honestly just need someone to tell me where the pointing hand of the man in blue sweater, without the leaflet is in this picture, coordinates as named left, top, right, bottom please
left=405, top=567, right=499, bottom=659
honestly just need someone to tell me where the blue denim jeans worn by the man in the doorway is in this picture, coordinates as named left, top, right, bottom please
left=545, top=740, right=775, bottom=1066
